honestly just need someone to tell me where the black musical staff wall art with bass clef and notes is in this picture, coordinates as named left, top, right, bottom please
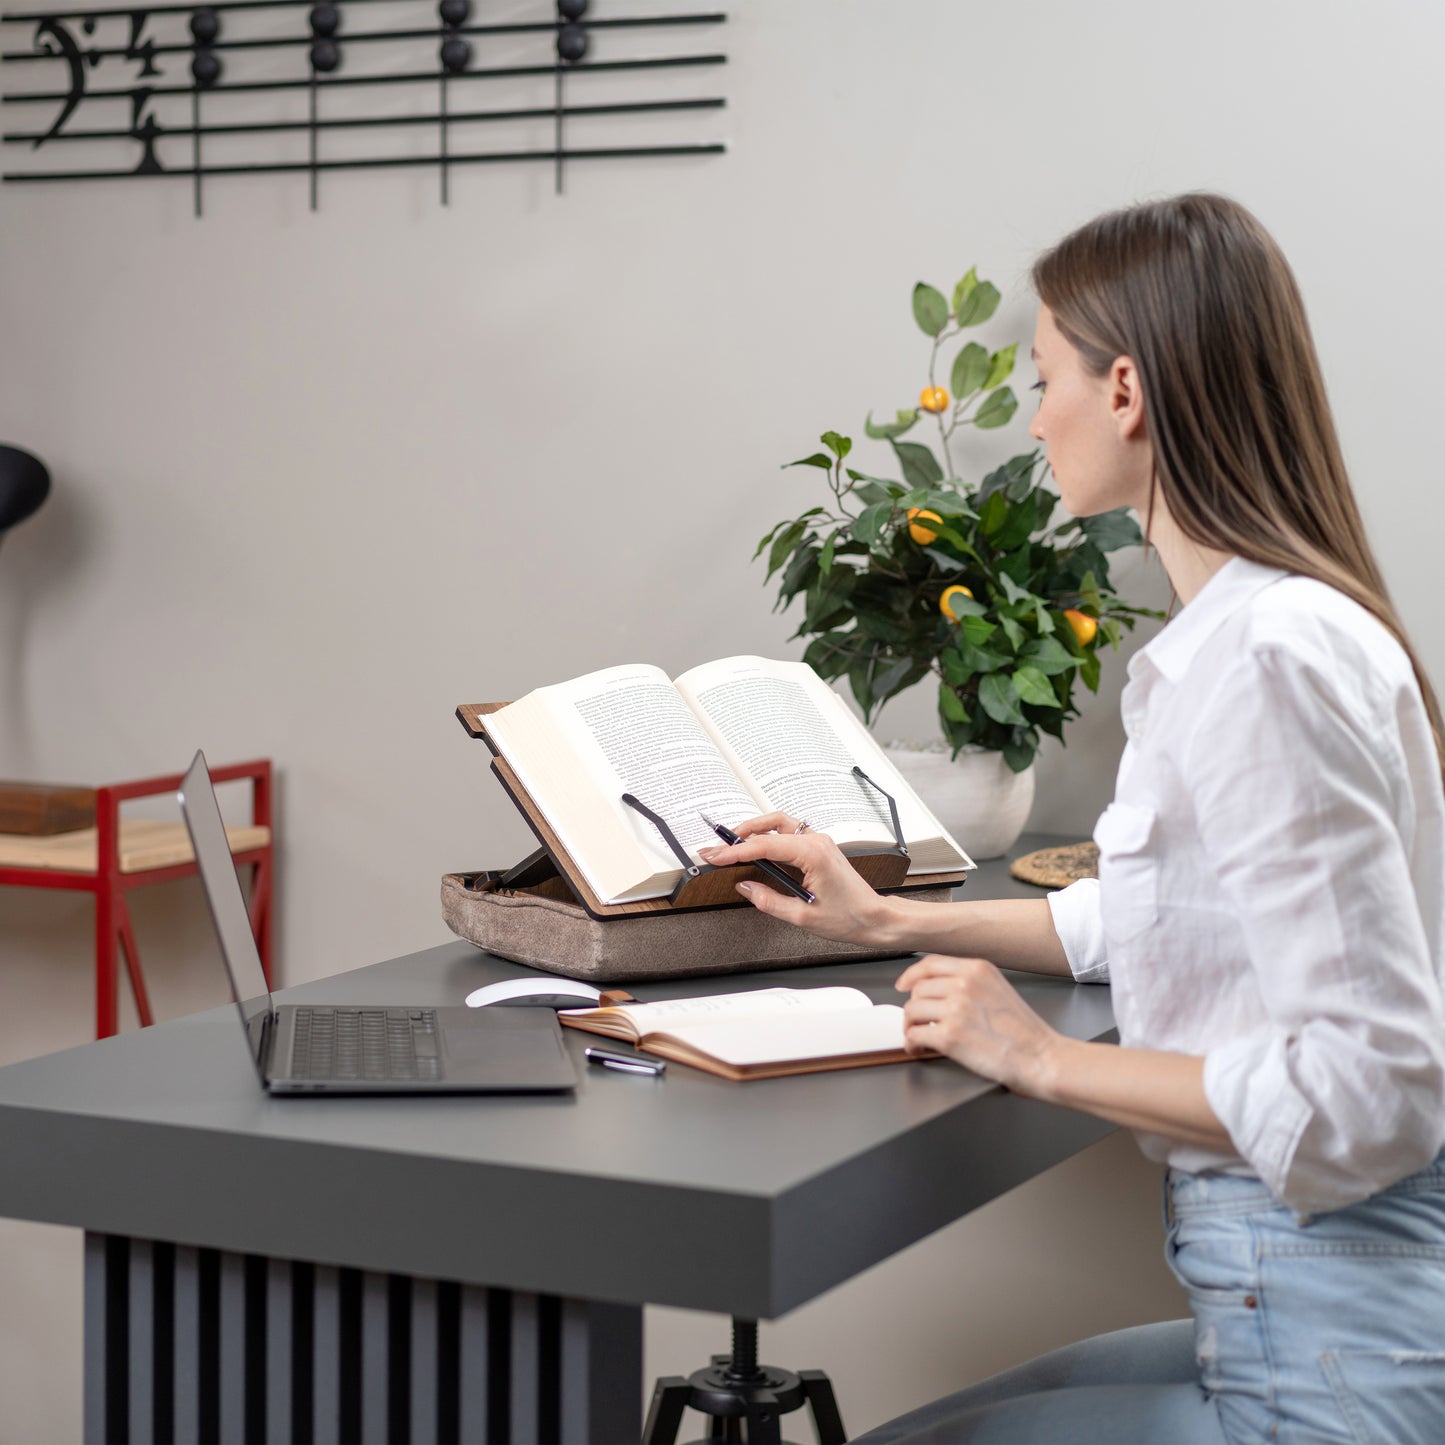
left=0, top=0, right=727, bottom=215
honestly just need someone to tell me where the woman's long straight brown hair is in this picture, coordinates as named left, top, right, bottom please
left=1033, top=194, right=1445, bottom=770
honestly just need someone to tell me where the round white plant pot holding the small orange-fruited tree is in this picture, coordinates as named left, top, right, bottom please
left=883, top=740, right=1033, bottom=863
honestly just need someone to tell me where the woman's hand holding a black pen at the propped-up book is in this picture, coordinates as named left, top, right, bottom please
left=699, top=814, right=890, bottom=946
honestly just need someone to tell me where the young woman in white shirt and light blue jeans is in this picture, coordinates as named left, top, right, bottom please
left=714, top=195, right=1445, bottom=1445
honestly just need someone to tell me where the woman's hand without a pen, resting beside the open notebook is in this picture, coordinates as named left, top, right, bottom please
left=894, top=954, right=1059, bottom=1095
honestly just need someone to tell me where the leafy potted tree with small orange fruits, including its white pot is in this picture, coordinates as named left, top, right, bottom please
left=754, top=270, right=1159, bottom=857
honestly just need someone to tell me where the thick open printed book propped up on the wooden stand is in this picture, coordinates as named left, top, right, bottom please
left=487, top=657, right=974, bottom=903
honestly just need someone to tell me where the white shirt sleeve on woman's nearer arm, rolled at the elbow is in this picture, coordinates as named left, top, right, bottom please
left=1184, top=649, right=1445, bottom=1214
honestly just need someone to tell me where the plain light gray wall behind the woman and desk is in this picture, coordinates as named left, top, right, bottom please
left=0, top=0, right=1445, bottom=1442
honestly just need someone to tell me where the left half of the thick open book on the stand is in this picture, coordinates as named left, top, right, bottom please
left=487, top=665, right=763, bottom=902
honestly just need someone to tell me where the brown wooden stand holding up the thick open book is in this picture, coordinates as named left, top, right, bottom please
left=457, top=702, right=968, bottom=919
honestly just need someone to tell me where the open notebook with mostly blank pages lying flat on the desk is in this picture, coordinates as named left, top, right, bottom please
left=558, top=988, right=932, bottom=1079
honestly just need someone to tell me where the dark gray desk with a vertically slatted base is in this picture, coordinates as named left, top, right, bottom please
left=0, top=837, right=1113, bottom=1445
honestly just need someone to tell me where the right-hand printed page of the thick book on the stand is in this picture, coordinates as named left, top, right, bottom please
left=676, top=657, right=971, bottom=873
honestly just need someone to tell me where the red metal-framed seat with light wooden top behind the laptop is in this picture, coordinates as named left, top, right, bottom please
left=0, top=759, right=275, bottom=1039
